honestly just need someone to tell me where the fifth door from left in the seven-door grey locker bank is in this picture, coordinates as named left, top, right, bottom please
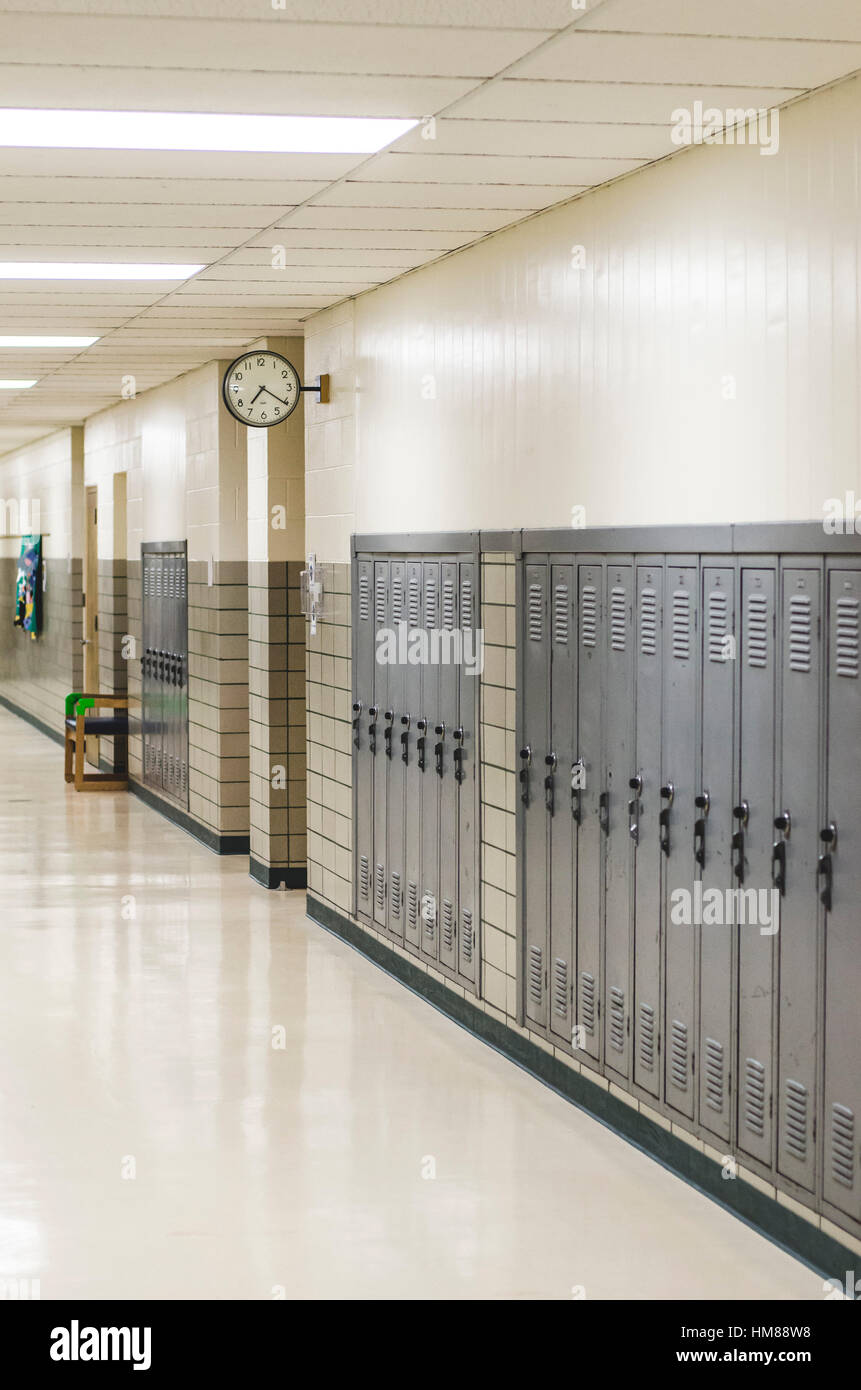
left=419, top=560, right=440, bottom=960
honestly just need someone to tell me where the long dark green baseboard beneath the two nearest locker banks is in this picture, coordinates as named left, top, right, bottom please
left=307, top=892, right=858, bottom=1279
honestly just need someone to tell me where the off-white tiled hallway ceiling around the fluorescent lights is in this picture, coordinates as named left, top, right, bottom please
left=0, top=0, right=861, bottom=452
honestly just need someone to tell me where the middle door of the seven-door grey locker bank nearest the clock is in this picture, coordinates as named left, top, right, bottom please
left=398, top=560, right=427, bottom=948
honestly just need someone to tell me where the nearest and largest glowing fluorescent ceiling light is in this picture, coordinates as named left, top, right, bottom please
left=0, top=107, right=419, bottom=154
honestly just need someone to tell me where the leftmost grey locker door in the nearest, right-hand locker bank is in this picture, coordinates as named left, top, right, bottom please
left=519, top=562, right=549, bottom=1024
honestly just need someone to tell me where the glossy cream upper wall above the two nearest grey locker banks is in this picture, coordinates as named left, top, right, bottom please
left=306, top=79, right=861, bottom=560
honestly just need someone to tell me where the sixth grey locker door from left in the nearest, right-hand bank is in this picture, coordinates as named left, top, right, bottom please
left=658, top=564, right=698, bottom=1119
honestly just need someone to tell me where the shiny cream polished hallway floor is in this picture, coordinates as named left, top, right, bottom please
left=0, top=709, right=822, bottom=1300
